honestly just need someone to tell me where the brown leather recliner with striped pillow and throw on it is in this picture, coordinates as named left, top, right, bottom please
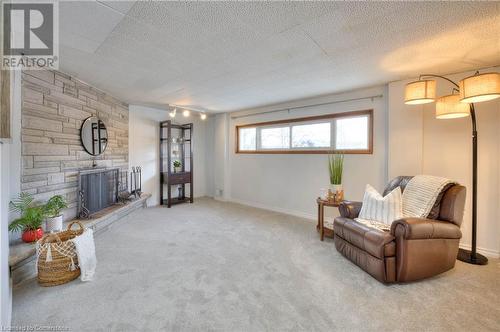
left=333, top=176, right=466, bottom=283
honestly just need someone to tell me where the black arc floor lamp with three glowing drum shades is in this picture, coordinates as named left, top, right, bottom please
left=405, top=72, right=500, bottom=265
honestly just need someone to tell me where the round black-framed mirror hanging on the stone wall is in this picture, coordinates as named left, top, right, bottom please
left=80, top=116, right=108, bottom=156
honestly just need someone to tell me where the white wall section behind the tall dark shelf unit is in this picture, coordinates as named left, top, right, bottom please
left=129, top=105, right=213, bottom=206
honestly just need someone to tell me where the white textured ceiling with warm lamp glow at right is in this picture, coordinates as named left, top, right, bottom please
left=59, top=1, right=500, bottom=111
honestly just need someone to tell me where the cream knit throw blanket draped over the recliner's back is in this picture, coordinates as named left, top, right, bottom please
left=403, top=175, right=454, bottom=218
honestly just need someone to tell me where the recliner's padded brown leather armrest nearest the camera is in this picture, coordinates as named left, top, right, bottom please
left=391, top=218, right=462, bottom=240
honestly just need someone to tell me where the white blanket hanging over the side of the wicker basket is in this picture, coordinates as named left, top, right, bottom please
left=72, top=229, right=97, bottom=281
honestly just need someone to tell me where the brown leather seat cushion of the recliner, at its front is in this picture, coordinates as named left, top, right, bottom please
left=333, top=217, right=396, bottom=258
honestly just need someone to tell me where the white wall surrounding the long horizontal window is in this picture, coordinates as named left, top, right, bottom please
left=215, top=87, right=387, bottom=218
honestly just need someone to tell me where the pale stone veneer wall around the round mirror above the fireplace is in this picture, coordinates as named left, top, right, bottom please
left=21, top=70, right=129, bottom=220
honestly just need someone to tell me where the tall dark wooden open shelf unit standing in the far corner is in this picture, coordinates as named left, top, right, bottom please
left=160, top=120, right=194, bottom=207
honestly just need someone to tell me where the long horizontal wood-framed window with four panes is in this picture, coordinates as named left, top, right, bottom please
left=236, top=110, right=373, bottom=154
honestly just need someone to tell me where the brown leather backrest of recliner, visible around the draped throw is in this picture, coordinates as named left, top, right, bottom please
left=384, top=176, right=466, bottom=226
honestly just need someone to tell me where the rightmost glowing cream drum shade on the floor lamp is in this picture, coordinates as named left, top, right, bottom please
left=458, top=73, right=500, bottom=103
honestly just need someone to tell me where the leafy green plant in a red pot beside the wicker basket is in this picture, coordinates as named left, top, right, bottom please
left=9, top=192, right=45, bottom=243
